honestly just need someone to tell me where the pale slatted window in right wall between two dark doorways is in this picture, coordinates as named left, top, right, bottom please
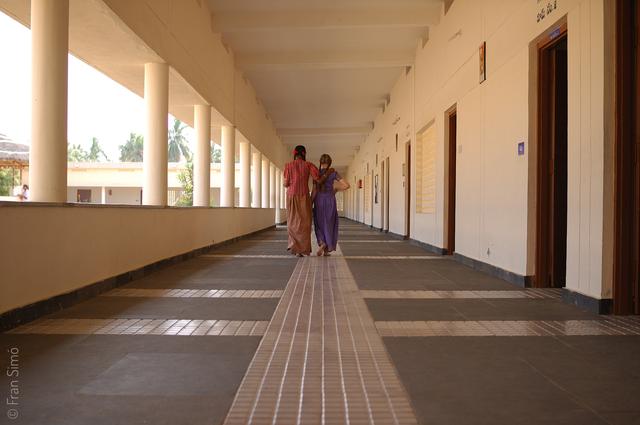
left=416, top=122, right=436, bottom=214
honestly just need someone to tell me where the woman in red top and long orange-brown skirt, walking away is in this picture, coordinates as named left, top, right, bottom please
left=284, top=146, right=320, bottom=257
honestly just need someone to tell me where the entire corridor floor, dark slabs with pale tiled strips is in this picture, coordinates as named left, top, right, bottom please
left=0, top=220, right=640, bottom=425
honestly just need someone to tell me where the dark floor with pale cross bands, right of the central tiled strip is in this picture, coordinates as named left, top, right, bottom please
left=343, top=227, right=640, bottom=425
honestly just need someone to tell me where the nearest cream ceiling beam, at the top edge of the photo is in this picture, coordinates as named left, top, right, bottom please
left=212, top=6, right=442, bottom=33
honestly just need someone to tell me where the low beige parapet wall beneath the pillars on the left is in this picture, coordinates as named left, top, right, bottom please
left=0, top=203, right=284, bottom=313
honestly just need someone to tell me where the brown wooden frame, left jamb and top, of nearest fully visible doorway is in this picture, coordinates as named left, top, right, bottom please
left=533, top=22, right=569, bottom=287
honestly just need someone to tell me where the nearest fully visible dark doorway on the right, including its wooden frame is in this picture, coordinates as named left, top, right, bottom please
left=534, top=26, right=568, bottom=288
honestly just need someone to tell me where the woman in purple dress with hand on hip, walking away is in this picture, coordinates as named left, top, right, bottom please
left=312, top=154, right=350, bottom=256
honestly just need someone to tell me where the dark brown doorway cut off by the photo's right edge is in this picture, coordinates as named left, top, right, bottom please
left=613, top=0, right=640, bottom=314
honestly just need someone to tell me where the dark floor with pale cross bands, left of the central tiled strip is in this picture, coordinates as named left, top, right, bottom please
left=0, top=237, right=296, bottom=425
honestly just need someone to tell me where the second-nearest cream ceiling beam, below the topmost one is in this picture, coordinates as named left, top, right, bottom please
left=236, top=51, right=414, bottom=71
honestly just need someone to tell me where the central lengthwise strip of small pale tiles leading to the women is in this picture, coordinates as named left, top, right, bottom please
left=225, top=256, right=417, bottom=425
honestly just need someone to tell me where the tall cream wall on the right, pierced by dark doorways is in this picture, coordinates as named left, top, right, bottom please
left=348, top=0, right=613, bottom=298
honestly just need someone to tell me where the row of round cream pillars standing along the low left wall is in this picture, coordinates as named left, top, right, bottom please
left=29, top=0, right=283, bottom=211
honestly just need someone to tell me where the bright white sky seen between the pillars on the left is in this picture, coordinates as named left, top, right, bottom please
left=0, top=12, right=195, bottom=161
